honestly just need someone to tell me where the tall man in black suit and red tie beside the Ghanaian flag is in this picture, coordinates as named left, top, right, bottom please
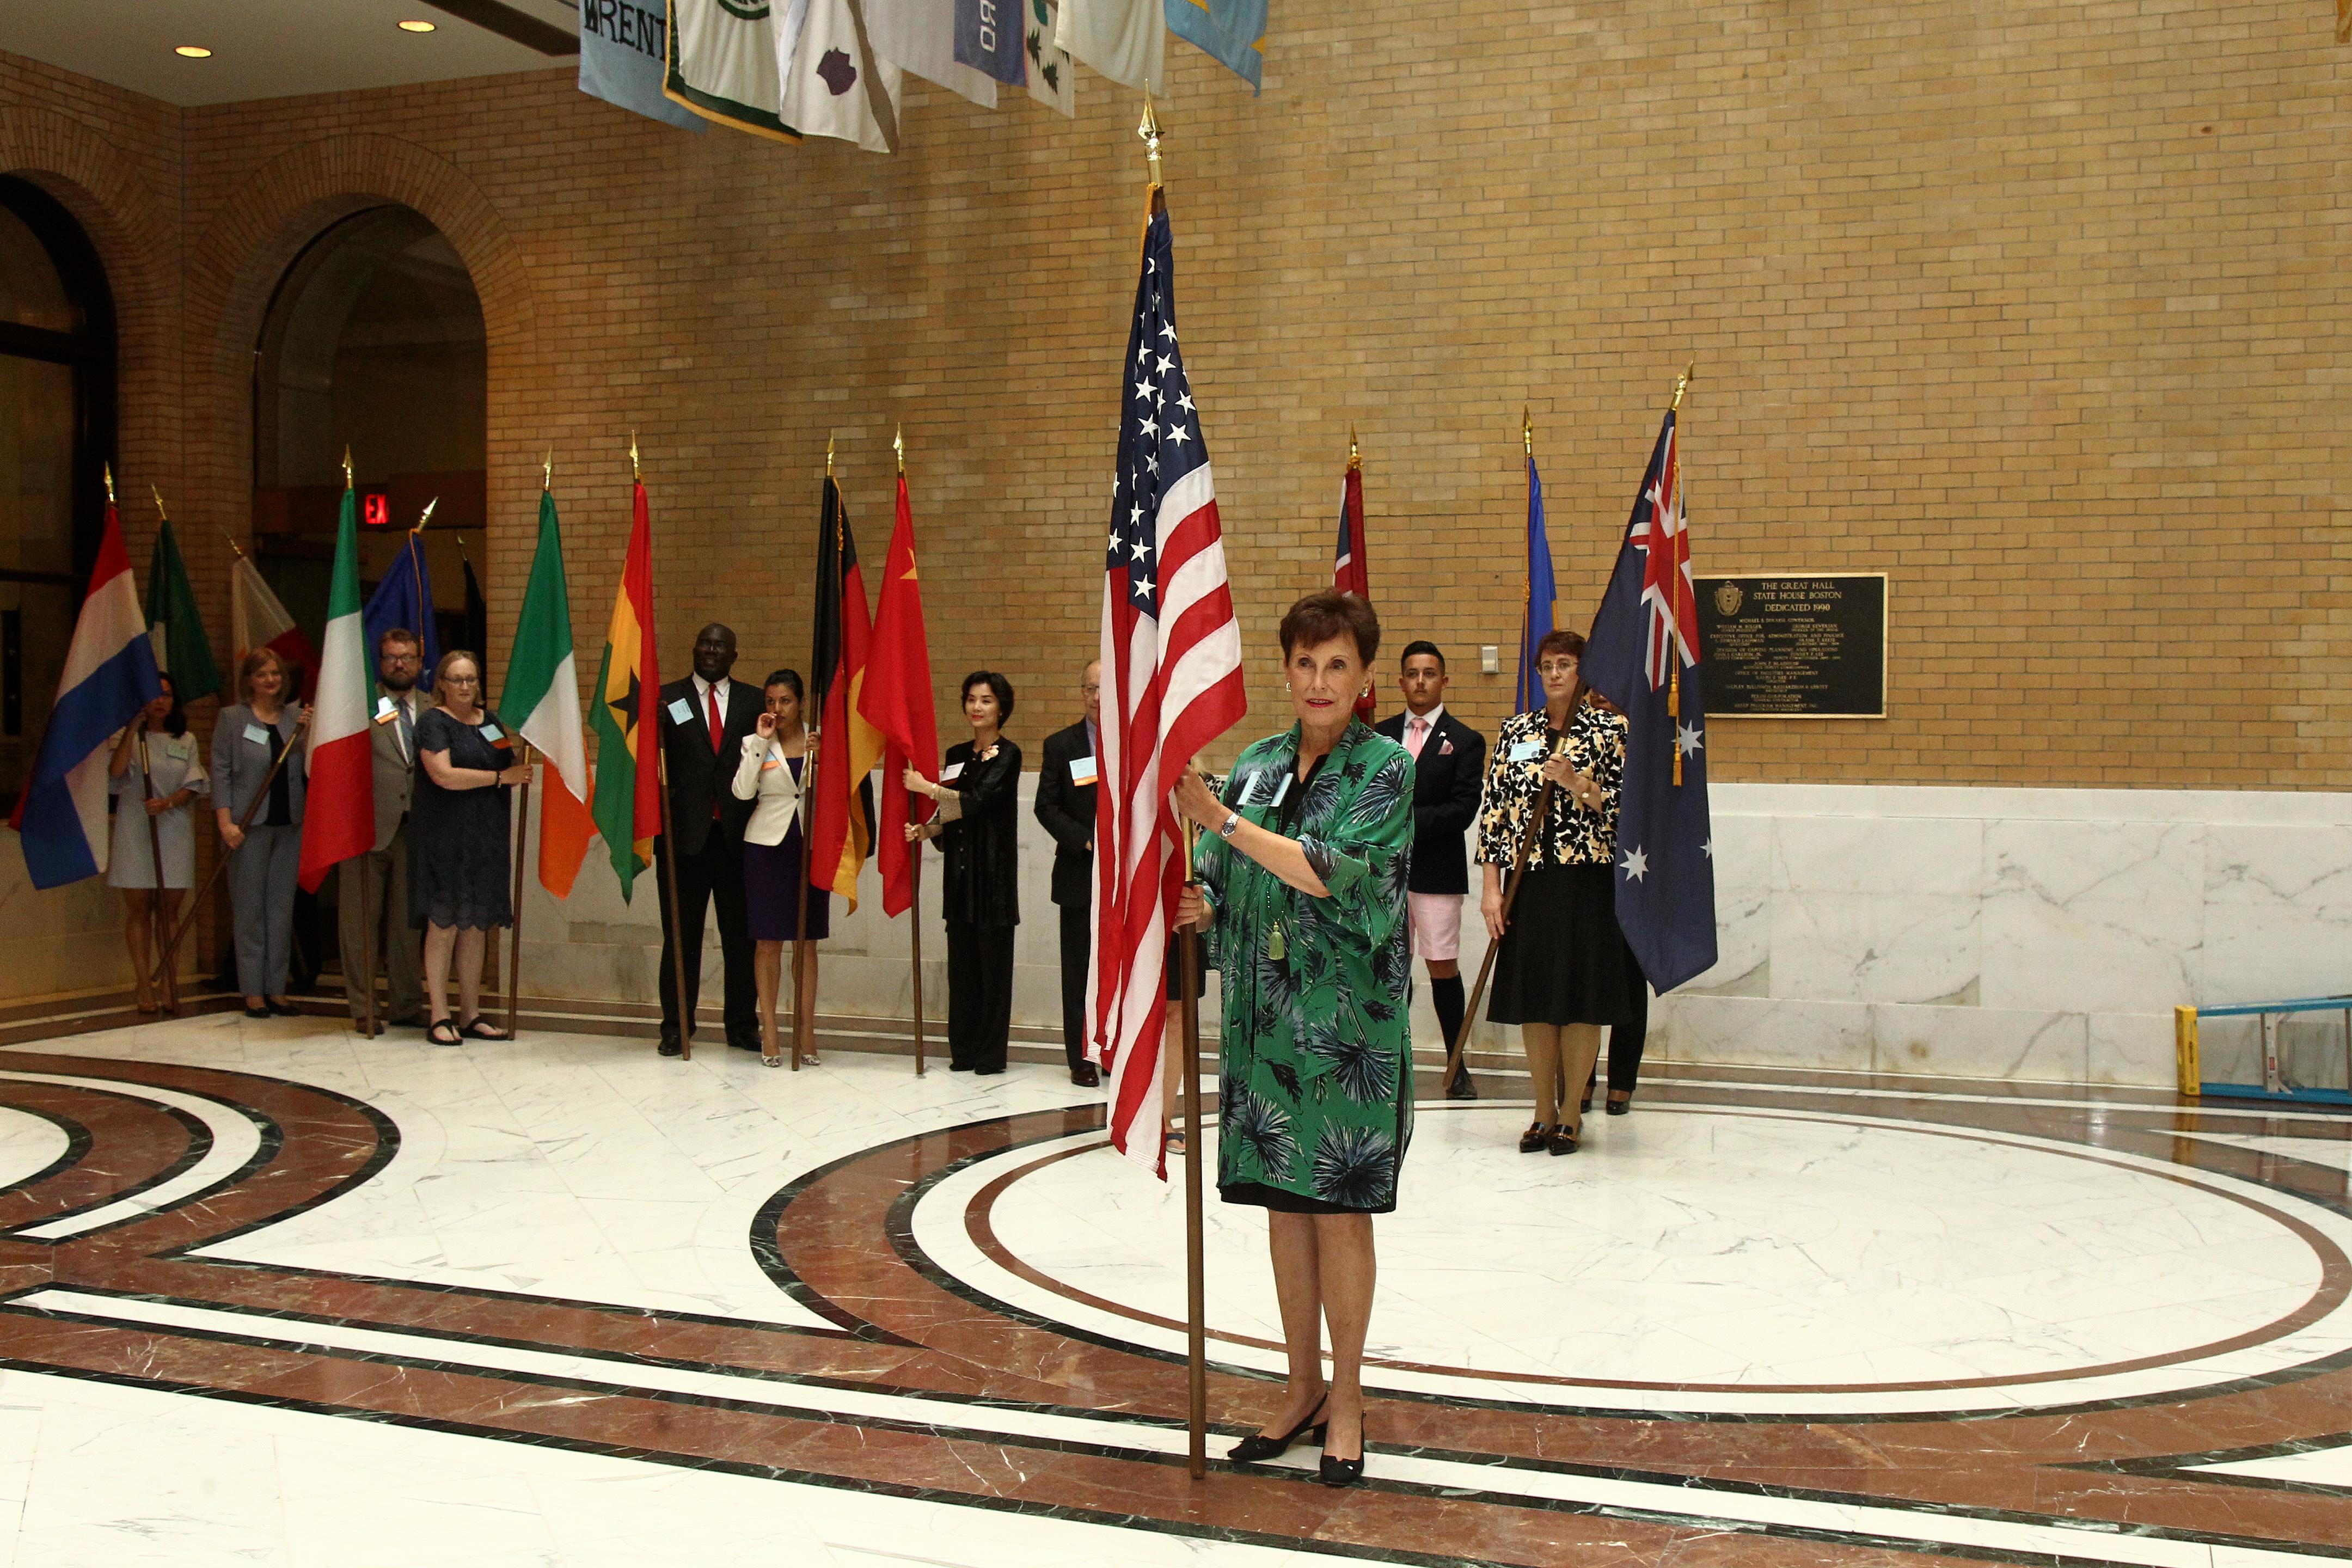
left=654, top=623, right=759, bottom=1056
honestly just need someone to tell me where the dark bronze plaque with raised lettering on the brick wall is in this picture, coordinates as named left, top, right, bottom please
left=1693, top=571, right=1886, bottom=719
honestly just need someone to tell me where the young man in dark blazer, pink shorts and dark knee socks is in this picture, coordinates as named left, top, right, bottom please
left=1374, top=642, right=1486, bottom=1100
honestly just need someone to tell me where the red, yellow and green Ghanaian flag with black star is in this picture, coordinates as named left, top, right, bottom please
left=588, top=472, right=661, bottom=898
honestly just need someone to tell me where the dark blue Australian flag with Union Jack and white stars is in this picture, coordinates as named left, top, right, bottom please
left=1583, top=414, right=1714, bottom=994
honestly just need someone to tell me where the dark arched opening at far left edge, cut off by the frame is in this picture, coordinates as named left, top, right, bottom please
left=0, top=179, right=115, bottom=808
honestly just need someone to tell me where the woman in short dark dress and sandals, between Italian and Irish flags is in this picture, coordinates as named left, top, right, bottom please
left=409, top=649, right=531, bottom=1046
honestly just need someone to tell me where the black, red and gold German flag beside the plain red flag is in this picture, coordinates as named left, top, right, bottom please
left=809, top=475, right=882, bottom=910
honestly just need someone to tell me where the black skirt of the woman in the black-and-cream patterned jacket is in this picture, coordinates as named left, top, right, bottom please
left=1486, top=865, right=1644, bottom=1025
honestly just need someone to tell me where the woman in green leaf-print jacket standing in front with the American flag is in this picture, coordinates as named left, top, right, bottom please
left=1176, top=592, right=1413, bottom=1486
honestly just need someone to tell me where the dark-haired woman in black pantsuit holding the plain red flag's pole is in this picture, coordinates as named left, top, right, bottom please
left=905, top=670, right=1021, bottom=1074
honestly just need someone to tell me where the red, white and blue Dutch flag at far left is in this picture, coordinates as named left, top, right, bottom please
left=7, top=501, right=162, bottom=889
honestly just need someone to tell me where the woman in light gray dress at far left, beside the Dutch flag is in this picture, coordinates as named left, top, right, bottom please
left=106, top=675, right=212, bottom=1013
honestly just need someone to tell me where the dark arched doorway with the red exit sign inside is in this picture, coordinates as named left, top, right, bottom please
left=254, top=207, right=489, bottom=677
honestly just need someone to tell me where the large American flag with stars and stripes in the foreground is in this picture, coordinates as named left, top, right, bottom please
left=1089, top=202, right=1247, bottom=1173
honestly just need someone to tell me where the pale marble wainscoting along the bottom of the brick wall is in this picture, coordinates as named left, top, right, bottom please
left=524, top=774, right=2352, bottom=1086
